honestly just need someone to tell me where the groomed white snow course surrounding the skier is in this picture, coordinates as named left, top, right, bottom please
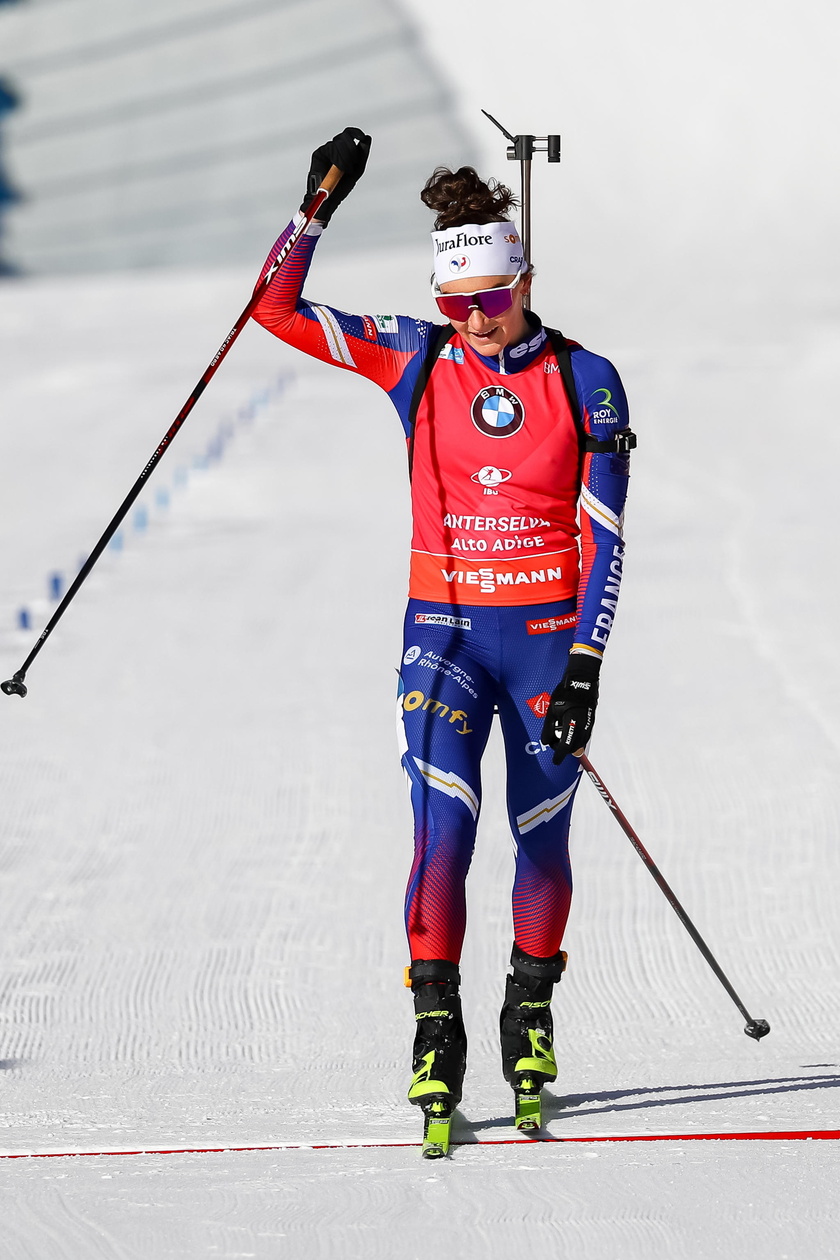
left=0, top=6, right=840, bottom=1260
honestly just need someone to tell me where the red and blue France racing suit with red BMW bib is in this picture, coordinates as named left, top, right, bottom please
left=254, top=216, right=628, bottom=963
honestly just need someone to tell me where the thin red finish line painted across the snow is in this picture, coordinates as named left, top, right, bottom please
left=0, top=1129, right=840, bottom=1159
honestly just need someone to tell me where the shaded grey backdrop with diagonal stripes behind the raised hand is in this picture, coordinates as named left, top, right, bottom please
left=0, top=0, right=467, bottom=271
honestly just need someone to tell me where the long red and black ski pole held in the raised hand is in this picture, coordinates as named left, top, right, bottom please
left=0, top=166, right=344, bottom=697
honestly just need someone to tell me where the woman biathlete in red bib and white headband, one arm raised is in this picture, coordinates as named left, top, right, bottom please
left=254, top=127, right=635, bottom=1154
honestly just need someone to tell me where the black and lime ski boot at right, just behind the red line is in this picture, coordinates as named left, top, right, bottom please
left=499, top=944, right=565, bottom=1133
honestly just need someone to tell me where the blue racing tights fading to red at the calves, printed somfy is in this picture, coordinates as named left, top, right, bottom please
left=398, top=600, right=579, bottom=963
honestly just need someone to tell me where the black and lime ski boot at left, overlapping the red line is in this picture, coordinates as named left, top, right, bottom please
left=406, top=959, right=467, bottom=1159
